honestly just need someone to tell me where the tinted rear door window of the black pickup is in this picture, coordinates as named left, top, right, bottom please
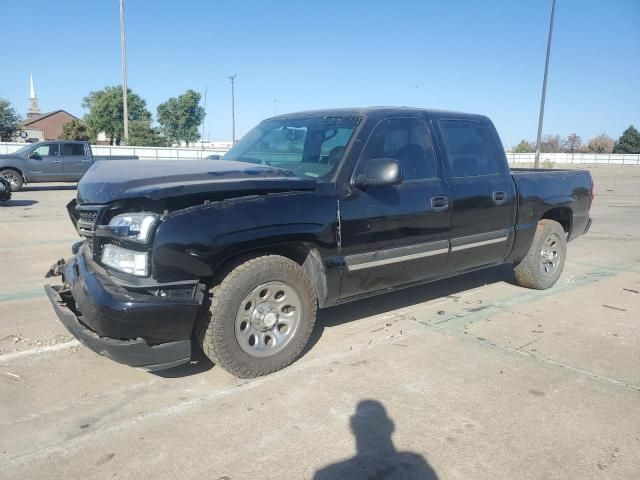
left=438, top=120, right=500, bottom=177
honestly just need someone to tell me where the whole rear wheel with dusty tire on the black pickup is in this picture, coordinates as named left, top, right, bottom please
left=513, top=219, right=567, bottom=290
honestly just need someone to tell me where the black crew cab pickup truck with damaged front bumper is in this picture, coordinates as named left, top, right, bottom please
left=46, top=108, right=593, bottom=377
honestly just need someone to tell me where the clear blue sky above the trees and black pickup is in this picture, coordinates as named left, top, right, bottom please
left=0, top=0, right=640, bottom=146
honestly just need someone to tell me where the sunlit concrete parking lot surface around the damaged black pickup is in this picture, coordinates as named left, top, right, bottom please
left=0, top=167, right=640, bottom=480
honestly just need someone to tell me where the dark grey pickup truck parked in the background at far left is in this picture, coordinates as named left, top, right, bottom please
left=0, top=140, right=138, bottom=192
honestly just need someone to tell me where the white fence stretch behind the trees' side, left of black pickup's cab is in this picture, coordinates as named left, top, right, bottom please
left=0, top=143, right=226, bottom=160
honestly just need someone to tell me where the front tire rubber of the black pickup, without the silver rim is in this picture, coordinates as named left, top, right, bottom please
left=195, top=255, right=318, bottom=378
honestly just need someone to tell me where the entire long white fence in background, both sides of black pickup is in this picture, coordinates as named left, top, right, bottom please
left=0, top=143, right=640, bottom=166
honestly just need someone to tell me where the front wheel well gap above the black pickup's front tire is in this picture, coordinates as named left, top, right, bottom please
left=216, top=243, right=327, bottom=307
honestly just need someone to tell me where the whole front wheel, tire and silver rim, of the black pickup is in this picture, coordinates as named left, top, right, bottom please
left=196, top=255, right=317, bottom=378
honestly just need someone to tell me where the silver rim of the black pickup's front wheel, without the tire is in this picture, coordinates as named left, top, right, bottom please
left=235, top=282, right=303, bottom=357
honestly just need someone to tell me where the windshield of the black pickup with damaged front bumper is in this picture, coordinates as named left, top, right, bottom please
left=223, top=116, right=360, bottom=179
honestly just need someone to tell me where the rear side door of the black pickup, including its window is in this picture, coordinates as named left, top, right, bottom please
left=437, top=118, right=515, bottom=272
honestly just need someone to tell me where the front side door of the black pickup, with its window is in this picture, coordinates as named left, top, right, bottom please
left=340, top=116, right=449, bottom=298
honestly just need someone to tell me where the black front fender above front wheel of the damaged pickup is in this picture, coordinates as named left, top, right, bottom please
left=152, top=192, right=337, bottom=282
